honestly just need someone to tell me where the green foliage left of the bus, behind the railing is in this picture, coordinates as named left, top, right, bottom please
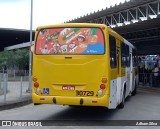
left=0, top=49, right=29, bottom=69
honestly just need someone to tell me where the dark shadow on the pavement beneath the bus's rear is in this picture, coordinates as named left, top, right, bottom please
left=42, top=106, right=119, bottom=120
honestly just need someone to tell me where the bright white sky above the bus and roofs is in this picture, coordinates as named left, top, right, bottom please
left=0, top=0, right=129, bottom=30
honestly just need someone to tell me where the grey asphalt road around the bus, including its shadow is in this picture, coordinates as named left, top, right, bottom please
left=0, top=89, right=160, bottom=129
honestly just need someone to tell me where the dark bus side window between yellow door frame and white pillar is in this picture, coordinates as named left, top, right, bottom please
left=121, top=42, right=130, bottom=68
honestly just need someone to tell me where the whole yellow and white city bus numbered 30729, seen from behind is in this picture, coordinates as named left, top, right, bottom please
left=32, top=23, right=138, bottom=109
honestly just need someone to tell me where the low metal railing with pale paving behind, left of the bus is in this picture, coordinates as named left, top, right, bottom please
left=0, top=70, right=31, bottom=104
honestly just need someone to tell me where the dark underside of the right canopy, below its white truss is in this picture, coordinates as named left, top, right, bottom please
left=114, top=18, right=160, bottom=55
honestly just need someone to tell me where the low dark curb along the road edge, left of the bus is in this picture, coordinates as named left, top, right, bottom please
left=0, top=98, right=32, bottom=111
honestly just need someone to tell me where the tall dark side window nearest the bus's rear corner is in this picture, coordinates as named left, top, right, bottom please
left=109, top=35, right=117, bottom=68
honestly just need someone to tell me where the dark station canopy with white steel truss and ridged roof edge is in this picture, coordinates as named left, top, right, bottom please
left=68, top=0, right=160, bottom=55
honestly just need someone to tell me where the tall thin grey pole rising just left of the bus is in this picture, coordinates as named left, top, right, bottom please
left=28, top=0, right=33, bottom=93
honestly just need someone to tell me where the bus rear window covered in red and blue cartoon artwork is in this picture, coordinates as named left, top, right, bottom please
left=36, top=28, right=105, bottom=55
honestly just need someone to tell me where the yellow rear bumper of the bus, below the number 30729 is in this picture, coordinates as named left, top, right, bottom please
left=32, top=93, right=109, bottom=107
